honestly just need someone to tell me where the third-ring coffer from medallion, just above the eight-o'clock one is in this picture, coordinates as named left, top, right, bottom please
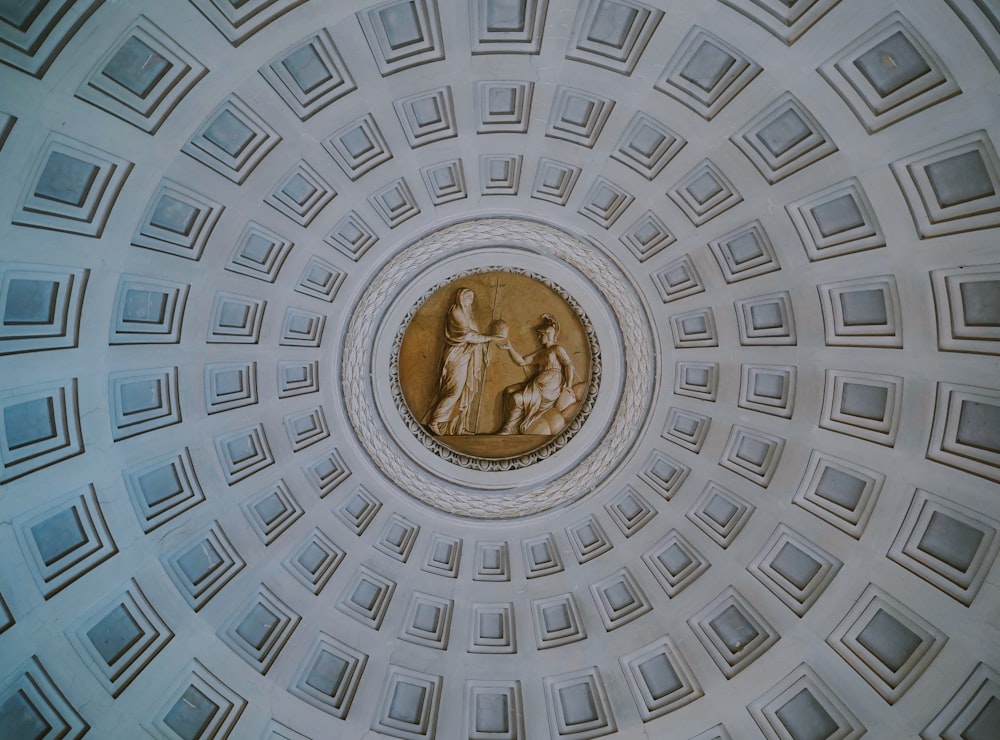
left=122, top=447, right=205, bottom=534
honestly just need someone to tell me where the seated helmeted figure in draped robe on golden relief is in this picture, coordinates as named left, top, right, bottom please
left=497, top=313, right=585, bottom=434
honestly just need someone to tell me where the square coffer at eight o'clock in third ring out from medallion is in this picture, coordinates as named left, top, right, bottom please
left=160, top=521, right=246, bottom=611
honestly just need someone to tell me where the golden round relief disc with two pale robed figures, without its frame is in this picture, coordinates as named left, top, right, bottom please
left=399, top=271, right=591, bottom=459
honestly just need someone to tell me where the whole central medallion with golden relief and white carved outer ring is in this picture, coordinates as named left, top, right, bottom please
left=341, top=218, right=657, bottom=518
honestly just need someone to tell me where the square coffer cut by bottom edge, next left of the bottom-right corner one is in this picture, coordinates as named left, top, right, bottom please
left=747, top=663, right=866, bottom=740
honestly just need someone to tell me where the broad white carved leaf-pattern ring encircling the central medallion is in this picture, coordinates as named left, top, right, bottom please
left=342, top=218, right=657, bottom=519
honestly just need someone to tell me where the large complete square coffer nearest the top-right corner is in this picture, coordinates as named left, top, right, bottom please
left=817, top=11, right=961, bottom=133
